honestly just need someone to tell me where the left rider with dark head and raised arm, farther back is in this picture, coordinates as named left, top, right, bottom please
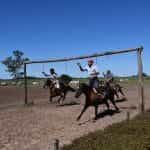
left=42, top=68, right=60, bottom=89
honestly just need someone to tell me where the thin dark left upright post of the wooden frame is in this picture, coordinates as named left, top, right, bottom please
left=24, top=63, right=28, bottom=104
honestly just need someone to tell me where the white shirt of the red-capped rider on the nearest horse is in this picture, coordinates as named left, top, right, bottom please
left=85, top=65, right=99, bottom=78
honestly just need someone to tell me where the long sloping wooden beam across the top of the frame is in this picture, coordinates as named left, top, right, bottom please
left=24, top=46, right=143, bottom=64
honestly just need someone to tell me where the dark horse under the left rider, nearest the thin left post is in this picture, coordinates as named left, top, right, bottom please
left=46, top=79, right=75, bottom=103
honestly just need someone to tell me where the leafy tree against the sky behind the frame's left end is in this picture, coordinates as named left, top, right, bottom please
left=2, top=50, right=29, bottom=79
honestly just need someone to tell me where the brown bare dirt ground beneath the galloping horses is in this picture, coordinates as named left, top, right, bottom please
left=0, top=83, right=150, bottom=150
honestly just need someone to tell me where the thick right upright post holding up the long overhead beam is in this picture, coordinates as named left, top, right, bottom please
left=137, top=47, right=145, bottom=112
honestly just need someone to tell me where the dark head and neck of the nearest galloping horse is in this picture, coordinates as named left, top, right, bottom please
left=75, top=83, right=89, bottom=98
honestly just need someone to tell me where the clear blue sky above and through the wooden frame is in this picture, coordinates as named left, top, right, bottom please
left=0, top=0, right=150, bottom=77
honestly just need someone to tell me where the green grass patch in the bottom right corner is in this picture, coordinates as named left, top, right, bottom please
left=63, top=112, right=150, bottom=150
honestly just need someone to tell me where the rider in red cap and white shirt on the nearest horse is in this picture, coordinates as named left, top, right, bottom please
left=77, top=60, right=99, bottom=94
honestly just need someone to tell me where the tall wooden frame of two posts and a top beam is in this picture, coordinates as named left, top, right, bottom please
left=24, top=46, right=145, bottom=112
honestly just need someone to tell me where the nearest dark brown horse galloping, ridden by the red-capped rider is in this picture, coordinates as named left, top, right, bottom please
left=75, top=83, right=119, bottom=121
